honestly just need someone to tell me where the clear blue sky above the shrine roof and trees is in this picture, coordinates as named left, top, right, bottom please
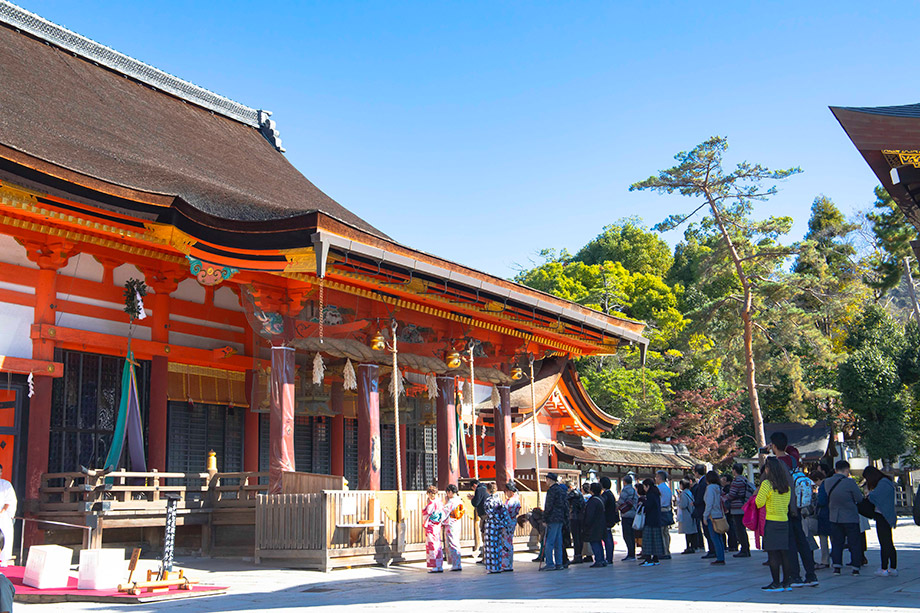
left=20, top=0, right=920, bottom=277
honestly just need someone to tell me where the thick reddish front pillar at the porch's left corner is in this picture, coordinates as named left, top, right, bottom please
left=268, top=347, right=294, bottom=494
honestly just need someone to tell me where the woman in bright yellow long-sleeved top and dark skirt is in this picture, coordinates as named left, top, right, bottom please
left=755, top=456, right=793, bottom=592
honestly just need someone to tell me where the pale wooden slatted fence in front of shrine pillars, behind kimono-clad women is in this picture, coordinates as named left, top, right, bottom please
left=255, top=490, right=537, bottom=570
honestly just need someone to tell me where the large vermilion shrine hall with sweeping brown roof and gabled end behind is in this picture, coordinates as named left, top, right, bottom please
left=0, top=2, right=647, bottom=552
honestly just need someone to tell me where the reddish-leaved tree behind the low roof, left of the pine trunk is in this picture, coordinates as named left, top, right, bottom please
left=653, top=388, right=744, bottom=465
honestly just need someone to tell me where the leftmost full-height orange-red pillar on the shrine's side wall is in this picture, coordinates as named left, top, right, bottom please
left=23, top=242, right=75, bottom=546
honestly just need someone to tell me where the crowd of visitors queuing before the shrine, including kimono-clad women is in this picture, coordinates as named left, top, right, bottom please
left=423, top=432, right=898, bottom=592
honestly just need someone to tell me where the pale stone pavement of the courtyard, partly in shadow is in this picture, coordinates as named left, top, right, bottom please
left=16, top=518, right=920, bottom=613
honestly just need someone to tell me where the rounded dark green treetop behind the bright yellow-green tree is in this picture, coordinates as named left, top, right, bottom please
left=572, top=217, right=673, bottom=277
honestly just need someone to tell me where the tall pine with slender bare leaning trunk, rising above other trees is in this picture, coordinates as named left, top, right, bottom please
left=630, top=137, right=800, bottom=446
